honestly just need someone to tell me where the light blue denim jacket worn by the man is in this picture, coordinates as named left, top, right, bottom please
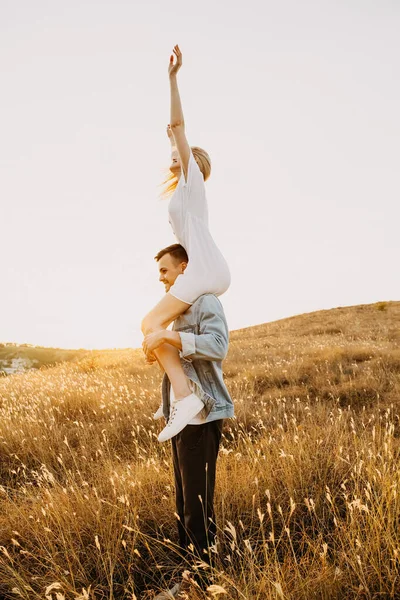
left=161, top=294, right=234, bottom=423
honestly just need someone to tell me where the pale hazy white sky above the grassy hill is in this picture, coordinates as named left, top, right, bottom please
left=0, top=0, right=400, bottom=349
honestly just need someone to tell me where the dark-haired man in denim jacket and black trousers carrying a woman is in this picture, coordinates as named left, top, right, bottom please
left=143, top=244, right=234, bottom=600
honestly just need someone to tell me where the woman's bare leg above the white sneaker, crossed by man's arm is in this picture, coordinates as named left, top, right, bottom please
left=141, top=292, right=191, bottom=400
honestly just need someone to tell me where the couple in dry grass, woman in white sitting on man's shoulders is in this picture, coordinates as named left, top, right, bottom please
left=141, top=46, right=234, bottom=600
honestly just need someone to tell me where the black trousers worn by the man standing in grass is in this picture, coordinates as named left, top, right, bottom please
left=171, top=419, right=224, bottom=576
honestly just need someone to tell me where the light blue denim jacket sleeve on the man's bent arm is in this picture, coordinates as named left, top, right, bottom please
left=179, top=294, right=229, bottom=362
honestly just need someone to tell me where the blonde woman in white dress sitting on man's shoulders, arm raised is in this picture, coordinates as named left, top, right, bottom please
left=141, top=46, right=231, bottom=441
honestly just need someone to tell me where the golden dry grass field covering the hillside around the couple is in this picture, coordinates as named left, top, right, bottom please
left=0, top=302, right=400, bottom=600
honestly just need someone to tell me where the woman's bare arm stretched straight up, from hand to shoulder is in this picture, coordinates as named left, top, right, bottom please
left=168, top=46, right=190, bottom=181
